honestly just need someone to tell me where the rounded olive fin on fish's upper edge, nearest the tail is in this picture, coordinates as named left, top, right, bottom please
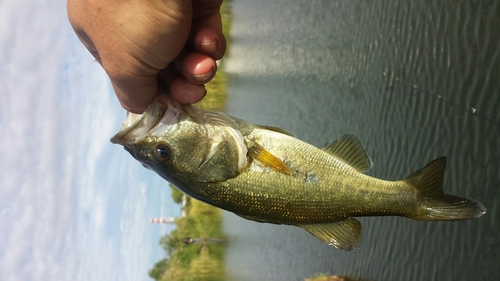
left=323, top=134, right=373, bottom=172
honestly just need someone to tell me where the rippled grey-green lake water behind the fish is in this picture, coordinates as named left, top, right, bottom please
left=224, top=0, right=500, bottom=280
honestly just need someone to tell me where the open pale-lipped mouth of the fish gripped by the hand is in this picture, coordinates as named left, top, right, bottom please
left=111, top=97, right=172, bottom=144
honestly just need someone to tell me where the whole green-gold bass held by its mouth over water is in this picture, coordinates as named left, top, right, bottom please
left=111, top=96, right=486, bottom=251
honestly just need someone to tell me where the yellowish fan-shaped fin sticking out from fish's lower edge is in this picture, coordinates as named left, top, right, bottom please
left=298, top=218, right=362, bottom=251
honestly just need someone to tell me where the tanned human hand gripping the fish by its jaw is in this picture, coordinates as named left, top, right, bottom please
left=67, top=0, right=226, bottom=113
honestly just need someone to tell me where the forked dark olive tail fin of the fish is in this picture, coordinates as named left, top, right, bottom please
left=404, top=157, right=486, bottom=221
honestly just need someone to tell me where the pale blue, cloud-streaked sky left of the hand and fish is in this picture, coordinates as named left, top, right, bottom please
left=0, top=0, right=180, bottom=281
